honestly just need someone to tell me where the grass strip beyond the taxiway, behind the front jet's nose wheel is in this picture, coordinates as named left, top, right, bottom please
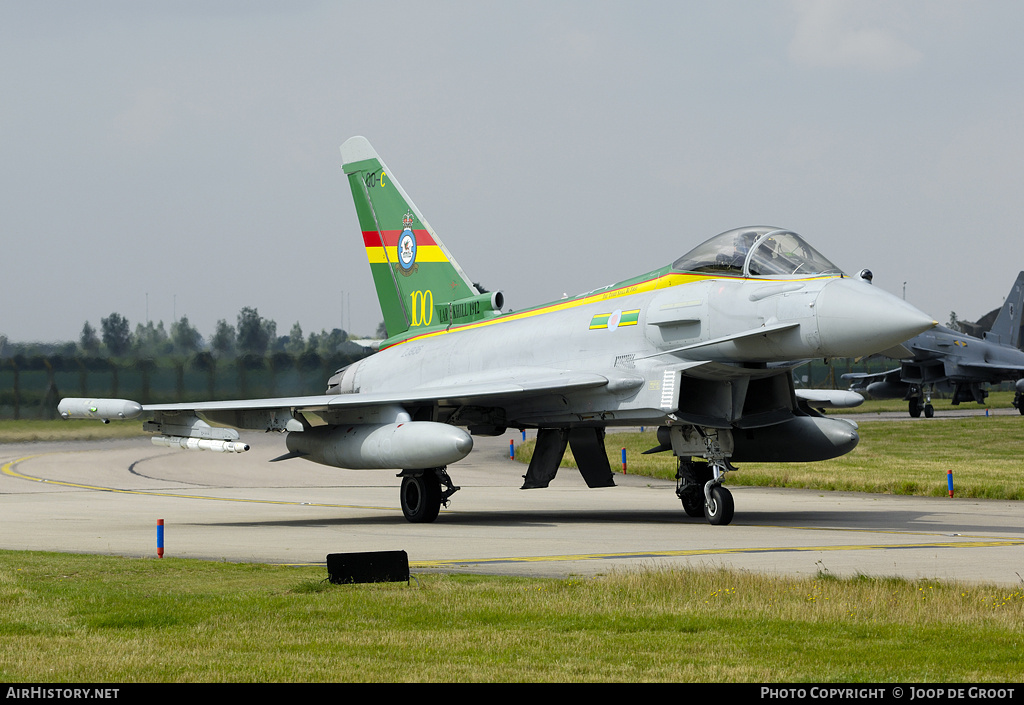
left=515, top=415, right=1024, bottom=499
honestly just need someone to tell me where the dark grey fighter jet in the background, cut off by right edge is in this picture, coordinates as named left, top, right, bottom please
left=843, top=272, right=1024, bottom=418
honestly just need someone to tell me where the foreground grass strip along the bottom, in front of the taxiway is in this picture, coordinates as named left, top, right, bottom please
left=0, top=551, right=1024, bottom=683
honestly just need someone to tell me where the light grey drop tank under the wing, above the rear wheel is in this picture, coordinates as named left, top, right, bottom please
left=287, top=421, right=473, bottom=469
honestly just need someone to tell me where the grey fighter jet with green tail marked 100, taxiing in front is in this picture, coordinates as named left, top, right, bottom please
left=58, top=137, right=935, bottom=525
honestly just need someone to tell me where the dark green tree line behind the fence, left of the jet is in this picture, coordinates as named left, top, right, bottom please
left=0, top=307, right=380, bottom=419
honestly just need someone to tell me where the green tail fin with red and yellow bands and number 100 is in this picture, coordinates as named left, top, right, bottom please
left=341, top=137, right=502, bottom=339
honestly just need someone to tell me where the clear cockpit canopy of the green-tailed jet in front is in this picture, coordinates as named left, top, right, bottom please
left=672, top=225, right=842, bottom=277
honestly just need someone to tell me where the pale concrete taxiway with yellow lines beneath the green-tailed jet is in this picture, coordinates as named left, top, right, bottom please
left=0, top=434, right=1024, bottom=585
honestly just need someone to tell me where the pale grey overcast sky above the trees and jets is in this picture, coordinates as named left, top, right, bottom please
left=0, top=0, right=1024, bottom=341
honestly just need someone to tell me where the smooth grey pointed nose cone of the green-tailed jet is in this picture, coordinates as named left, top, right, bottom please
left=815, top=279, right=936, bottom=358
